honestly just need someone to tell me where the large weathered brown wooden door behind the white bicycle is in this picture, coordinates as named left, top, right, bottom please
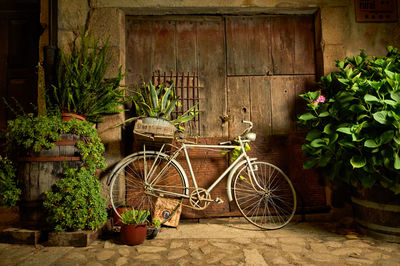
left=126, top=16, right=326, bottom=218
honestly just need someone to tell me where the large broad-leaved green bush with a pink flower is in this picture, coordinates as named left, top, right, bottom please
left=298, top=47, right=400, bottom=194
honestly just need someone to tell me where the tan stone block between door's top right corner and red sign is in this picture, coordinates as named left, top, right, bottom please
left=321, top=7, right=351, bottom=44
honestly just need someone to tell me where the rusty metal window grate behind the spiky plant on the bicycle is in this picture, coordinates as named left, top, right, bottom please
left=152, top=71, right=200, bottom=135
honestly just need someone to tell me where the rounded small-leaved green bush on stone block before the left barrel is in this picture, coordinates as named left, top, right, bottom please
left=43, top=167, right=107, bottom=232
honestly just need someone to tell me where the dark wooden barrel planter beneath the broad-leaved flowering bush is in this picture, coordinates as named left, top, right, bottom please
left=351, top=186, right=400, bottom=243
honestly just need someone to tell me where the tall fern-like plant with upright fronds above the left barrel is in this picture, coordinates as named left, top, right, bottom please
left=46, top=30, right=125, bottom=123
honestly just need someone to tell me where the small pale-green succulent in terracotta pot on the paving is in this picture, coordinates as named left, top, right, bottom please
left=120, top=207, right=150, bottom=245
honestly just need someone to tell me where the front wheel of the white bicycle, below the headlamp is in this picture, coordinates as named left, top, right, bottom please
left=233, top=162, right=297, bottom=229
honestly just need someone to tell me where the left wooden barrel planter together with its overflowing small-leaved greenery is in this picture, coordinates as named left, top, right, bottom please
left=5, top=114, right=106, bottom=231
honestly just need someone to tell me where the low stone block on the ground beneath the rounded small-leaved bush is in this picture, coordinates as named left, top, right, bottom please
left=47, top=230, right=99, bottom=247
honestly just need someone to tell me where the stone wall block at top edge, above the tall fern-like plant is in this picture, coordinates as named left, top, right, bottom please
left=58, top=0, right=90, bottom=30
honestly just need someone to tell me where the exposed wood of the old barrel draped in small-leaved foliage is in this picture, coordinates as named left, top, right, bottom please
left=18, top=134, right=81, bottom=228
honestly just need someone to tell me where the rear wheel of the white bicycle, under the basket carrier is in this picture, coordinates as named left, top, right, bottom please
left=110, top=151, right=187, bottom=223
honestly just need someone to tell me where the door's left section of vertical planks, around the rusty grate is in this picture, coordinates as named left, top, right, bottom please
left=126, top=17, right=227, bottom=137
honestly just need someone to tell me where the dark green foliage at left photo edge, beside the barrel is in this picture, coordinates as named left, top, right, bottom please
left=0, top=156, right=21, bottom=207
